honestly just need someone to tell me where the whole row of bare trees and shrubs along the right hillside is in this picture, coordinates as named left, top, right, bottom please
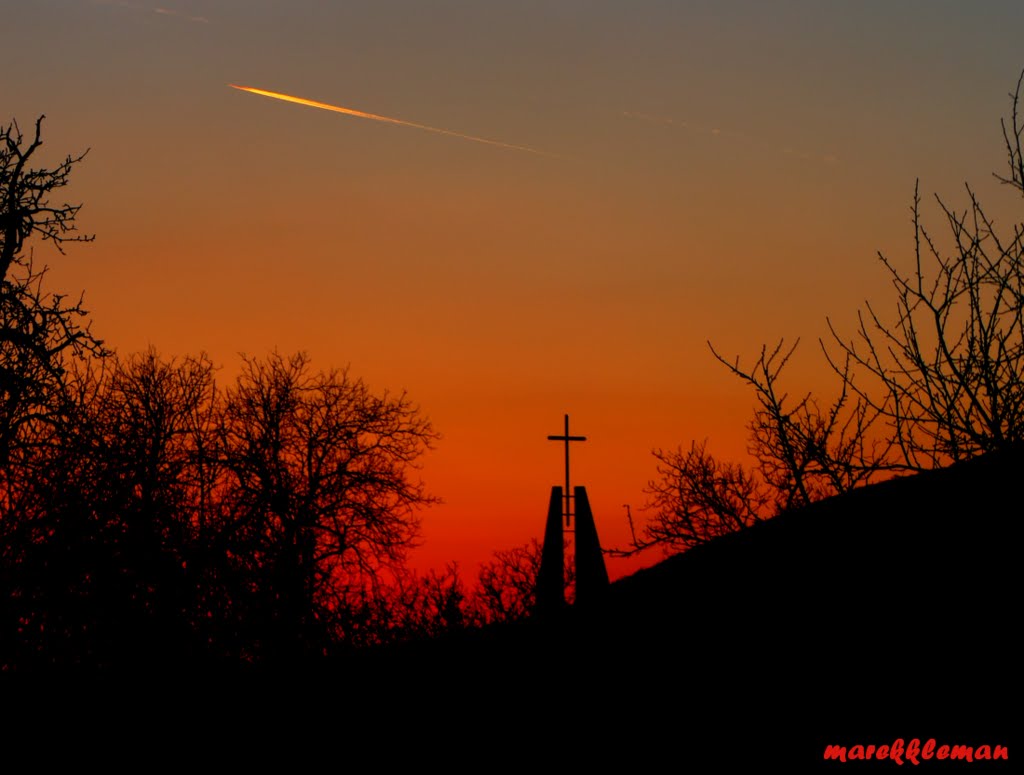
left=617, top=73, right=1024, bottom=554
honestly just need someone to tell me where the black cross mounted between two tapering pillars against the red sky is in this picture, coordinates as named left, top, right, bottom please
left=537, top=415, right=608, bottom=615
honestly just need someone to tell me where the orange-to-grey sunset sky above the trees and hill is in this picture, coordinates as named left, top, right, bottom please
left=0, top=0, right=1024, bottom=576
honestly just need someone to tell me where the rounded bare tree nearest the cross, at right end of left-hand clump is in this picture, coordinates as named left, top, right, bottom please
left=220, top=354, right=437, bottom=655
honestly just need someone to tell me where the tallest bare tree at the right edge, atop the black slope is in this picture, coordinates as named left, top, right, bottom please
left=826, top=73, right=1024, bottom=471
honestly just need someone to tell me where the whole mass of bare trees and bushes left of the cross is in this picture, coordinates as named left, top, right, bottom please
left=0, top=117, right=571, bottom=672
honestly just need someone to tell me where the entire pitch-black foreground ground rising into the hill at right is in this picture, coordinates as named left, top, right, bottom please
left=5, top=454, right=1024, bottom=772
